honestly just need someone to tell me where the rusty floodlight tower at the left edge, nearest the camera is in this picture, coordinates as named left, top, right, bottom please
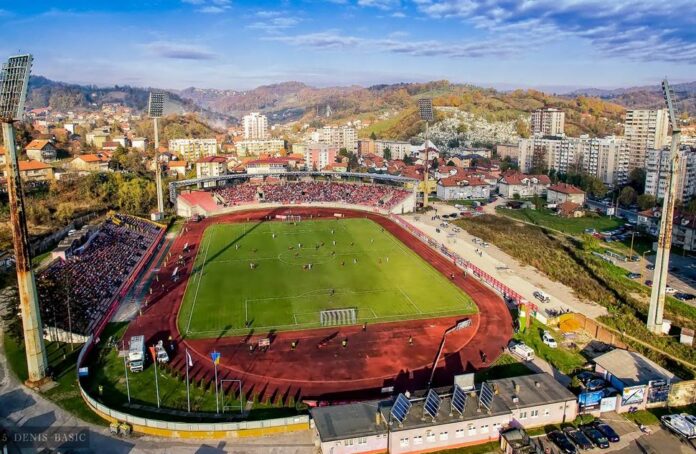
left=0, top=54, right=48, bottom=387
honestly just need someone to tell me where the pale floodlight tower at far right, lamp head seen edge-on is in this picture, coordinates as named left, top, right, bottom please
left=647, top=79, right=681, bottom=334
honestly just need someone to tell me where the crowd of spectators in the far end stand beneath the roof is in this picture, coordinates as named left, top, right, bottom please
left=215, top=181, right=411, bottom=210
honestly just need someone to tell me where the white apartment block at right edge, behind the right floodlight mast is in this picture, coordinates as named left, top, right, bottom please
left=645, top=147, right=696, bottom=202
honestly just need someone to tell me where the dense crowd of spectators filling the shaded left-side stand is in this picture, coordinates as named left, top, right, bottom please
left=37, top=214, right=161, bottom=335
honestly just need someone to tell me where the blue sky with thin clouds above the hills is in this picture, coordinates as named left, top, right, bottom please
left=0, top=0, right=696, bottom=91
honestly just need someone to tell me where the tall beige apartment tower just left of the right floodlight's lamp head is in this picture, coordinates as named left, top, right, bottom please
left=624, top=109, right=669, bottom=172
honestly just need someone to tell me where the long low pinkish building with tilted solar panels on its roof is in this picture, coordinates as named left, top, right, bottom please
left=311, top=373, right=577, bottom=454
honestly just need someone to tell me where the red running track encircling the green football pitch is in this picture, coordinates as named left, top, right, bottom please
left=126, top=207, right=512, bottom=401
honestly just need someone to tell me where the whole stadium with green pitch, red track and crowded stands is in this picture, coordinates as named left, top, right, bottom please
left=39, top=172, right=512, bottom=402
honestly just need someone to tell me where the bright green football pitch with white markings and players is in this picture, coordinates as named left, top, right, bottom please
left=178, top=218, right=476, bottom=338
